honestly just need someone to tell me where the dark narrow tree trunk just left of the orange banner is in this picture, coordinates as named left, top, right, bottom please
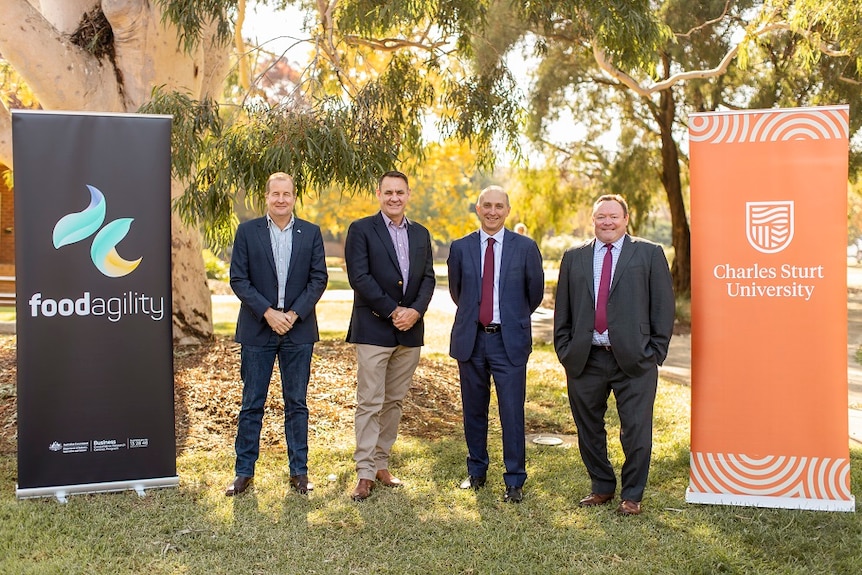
left=656, top=89, right=691, bottom=297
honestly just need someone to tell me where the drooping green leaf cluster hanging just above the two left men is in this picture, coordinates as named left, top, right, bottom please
left=142, top=91, right=399, bottom=247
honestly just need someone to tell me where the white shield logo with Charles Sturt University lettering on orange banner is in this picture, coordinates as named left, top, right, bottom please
left=712, top=201, right=825, bottom=301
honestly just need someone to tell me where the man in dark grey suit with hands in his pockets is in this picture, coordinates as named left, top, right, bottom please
left=554, top=195, right=675, bottom=515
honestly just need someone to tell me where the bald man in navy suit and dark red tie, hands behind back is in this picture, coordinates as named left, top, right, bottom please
left=448, top=186, right=545, bottom=503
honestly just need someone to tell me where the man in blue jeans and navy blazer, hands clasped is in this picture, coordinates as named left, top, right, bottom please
left=225, top=172, right=328, bottom=497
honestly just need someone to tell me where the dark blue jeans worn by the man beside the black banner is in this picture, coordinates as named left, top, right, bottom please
left=235, top=333, right=314, bottom=477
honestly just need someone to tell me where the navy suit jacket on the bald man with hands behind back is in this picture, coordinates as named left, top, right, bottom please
left=447, top=229, right=545, bottom=365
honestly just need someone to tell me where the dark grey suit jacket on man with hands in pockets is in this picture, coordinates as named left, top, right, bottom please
left=554, top=235, right=676, bottom=377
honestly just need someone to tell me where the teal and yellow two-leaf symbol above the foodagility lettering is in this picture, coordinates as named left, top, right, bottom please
left=54, top=184, right=143, bottom=278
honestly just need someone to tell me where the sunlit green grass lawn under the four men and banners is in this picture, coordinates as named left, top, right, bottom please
left=0, top=294, right=862, bottom=575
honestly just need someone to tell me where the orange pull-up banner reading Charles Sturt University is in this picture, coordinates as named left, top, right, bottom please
left=686, top=106, right=856, bottom=511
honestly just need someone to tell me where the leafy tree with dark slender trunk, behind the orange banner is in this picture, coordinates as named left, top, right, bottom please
left=506, top=0, right=862, bottom=294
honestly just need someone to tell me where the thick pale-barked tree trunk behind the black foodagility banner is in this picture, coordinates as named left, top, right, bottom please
left=0, top=0, right=223, bottom=344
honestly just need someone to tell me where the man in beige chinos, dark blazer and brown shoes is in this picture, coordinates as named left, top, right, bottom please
left=344, top=171, right=436, bottom=501
